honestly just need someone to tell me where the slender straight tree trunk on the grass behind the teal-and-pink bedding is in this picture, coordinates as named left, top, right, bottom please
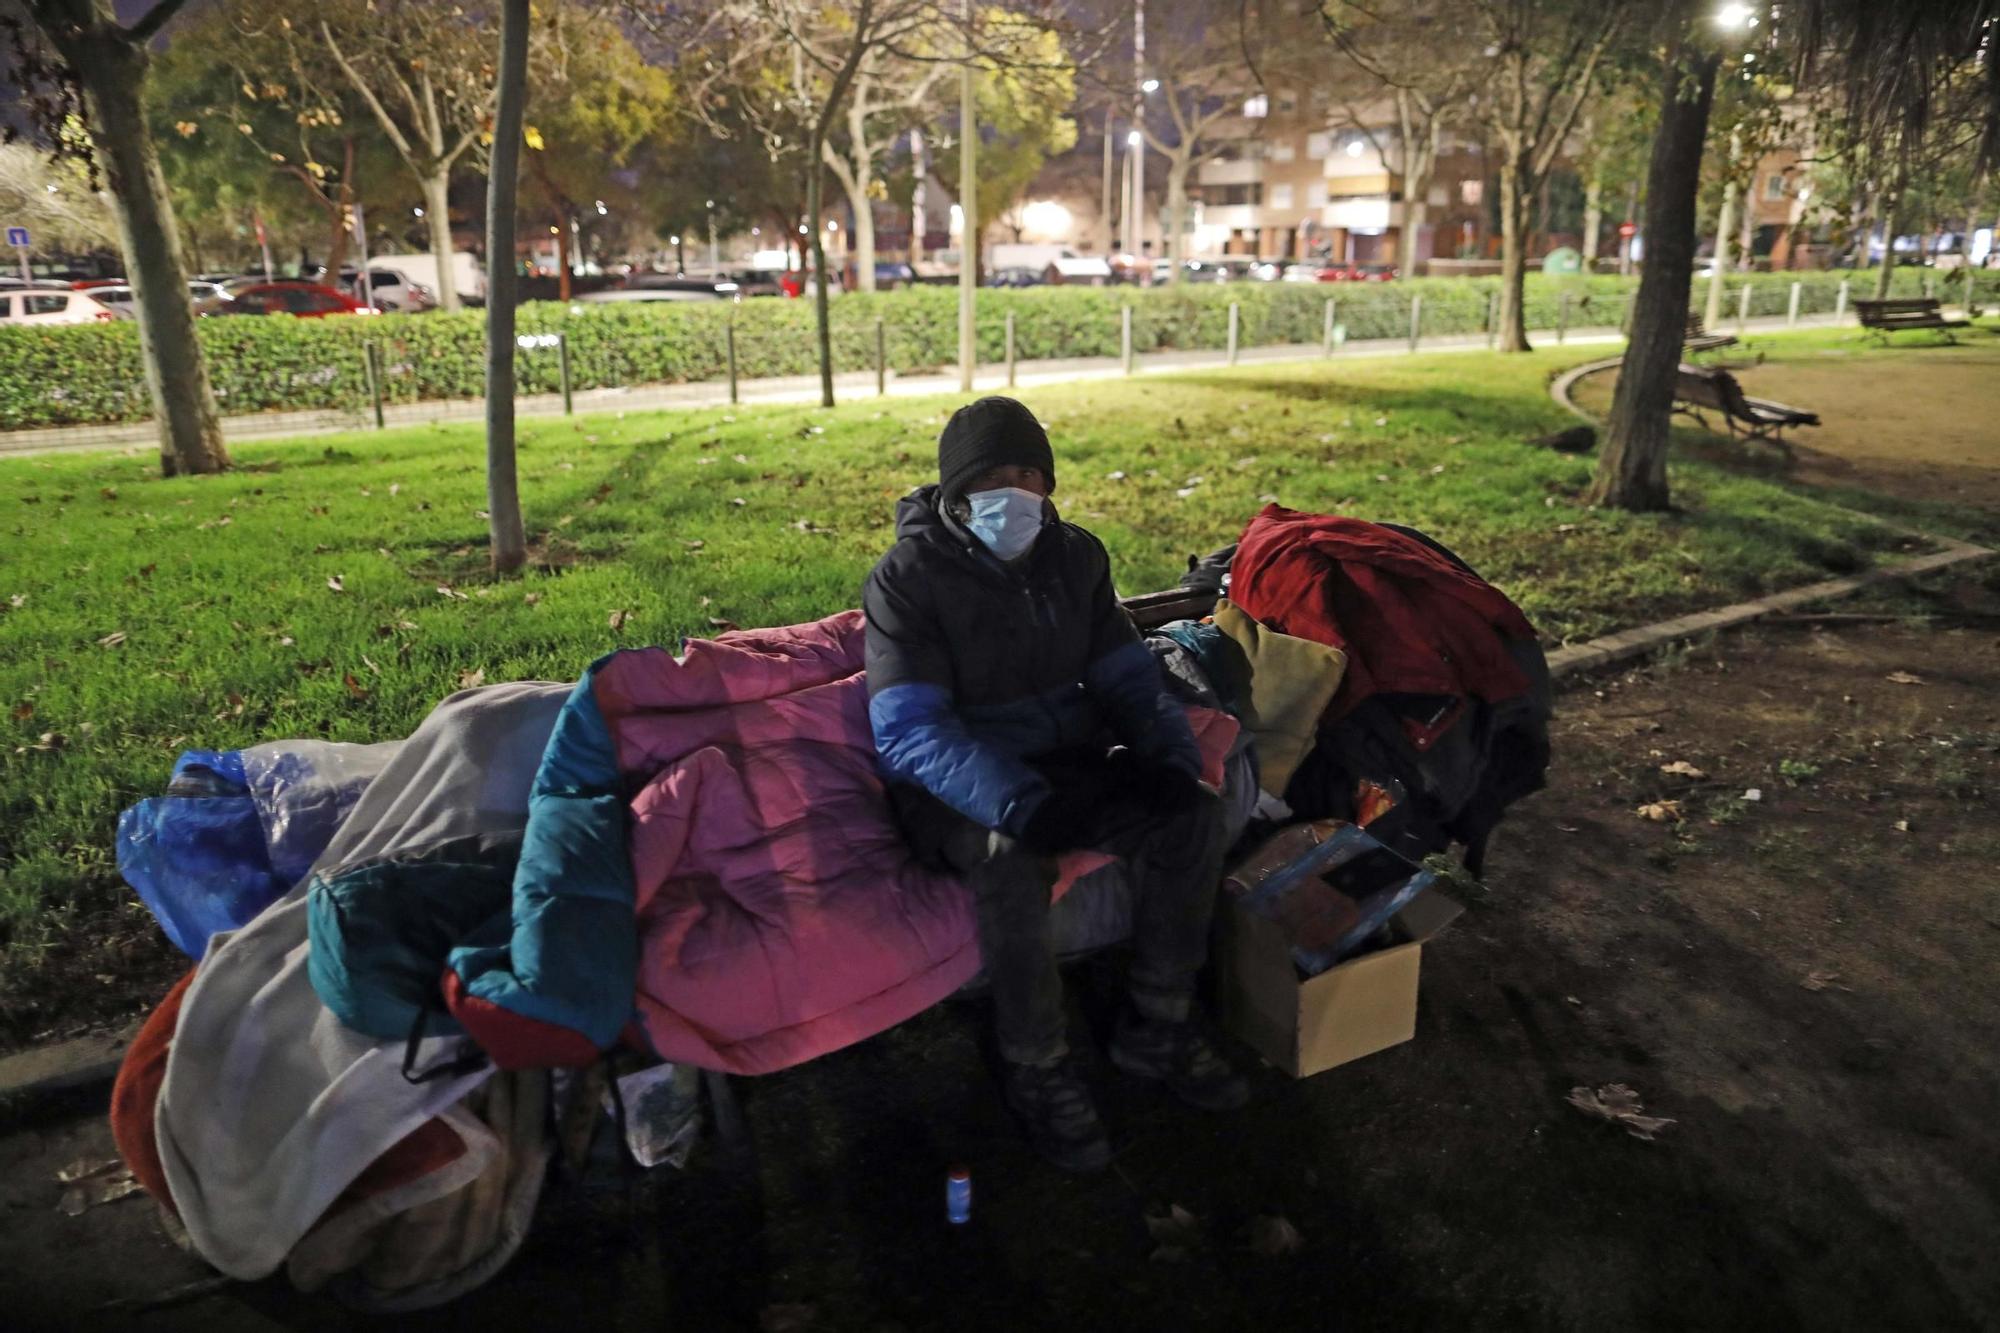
left=486, top=0, right=528, bottom=574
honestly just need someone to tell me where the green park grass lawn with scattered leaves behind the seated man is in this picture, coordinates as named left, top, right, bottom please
left=0, top=332, right=1936, bottom=1041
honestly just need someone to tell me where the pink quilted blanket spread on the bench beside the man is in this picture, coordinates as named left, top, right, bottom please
left=596, top=610, right=1236, bottom=1073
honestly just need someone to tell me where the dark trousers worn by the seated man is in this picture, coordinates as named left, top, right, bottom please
left=934, top=791, right=1228, bottom=1065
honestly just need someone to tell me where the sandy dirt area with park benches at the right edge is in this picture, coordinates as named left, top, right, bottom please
left=1576, top=334, right=2000, bottom=514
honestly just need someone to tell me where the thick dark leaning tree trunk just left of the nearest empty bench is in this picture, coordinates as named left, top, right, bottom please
left=1590, top=40, right=1720, bottom=510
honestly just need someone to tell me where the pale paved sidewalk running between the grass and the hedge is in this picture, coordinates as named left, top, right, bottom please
left=0, top=314, right=1852, bottom=456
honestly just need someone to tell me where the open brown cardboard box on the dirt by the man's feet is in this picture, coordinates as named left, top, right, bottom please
left=1218, top=889, right=1464, bottom=1079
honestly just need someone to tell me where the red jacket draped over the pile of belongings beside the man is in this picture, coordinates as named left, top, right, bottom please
left=1228, top=504, right=1534, bottom=720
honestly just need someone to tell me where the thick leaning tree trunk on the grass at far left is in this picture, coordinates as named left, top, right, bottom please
left=66, top=23, right=230, bottom=476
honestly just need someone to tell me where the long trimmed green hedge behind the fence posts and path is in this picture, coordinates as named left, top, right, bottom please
left=0, top=268, right=2000, bottom=430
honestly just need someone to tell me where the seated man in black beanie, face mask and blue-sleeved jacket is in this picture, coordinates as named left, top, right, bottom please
left=862, top=398, right=1248, bottom=1171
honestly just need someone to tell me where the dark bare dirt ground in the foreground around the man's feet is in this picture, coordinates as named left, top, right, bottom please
left=0, top=370, right=2000, bottom=1333
